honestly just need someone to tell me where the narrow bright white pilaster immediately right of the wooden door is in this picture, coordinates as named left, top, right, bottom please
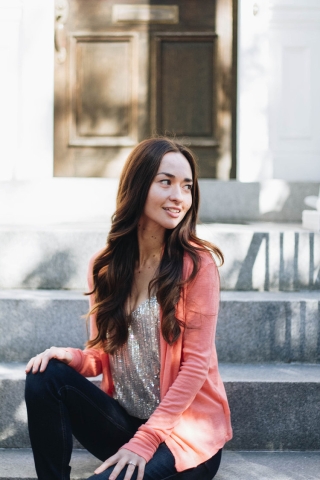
left=237, top=0, right=273, bottom=182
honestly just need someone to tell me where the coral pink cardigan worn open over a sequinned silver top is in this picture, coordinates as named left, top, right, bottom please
left=68, top=252, right=232, bottom=472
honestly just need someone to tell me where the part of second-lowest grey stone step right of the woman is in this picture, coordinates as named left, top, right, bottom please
left=220, top=364, right=320, bottom=451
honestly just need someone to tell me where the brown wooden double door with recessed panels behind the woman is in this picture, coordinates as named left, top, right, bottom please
left=55, top=0, right=234, bottom=179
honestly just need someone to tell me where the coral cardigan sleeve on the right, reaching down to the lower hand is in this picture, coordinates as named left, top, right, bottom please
left=122, top=260, right=220, bottom=462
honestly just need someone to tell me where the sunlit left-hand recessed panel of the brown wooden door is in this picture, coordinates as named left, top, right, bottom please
left=69, top=35, right=137, bottom=146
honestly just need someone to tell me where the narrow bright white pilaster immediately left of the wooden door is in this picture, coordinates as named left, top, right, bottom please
left=15, top=0, right=54, bottom=180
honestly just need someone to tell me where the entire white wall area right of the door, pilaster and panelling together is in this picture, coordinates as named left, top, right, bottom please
left=238, top=0, right=320, bottom=182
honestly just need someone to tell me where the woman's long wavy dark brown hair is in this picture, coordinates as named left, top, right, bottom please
left=87, top=137, right=223, bottom=354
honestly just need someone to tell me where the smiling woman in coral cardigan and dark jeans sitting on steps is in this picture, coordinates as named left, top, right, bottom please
left=26, top=138, right=232, bottom=480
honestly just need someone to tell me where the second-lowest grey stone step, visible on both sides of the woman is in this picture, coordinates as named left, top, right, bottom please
left=0, top=363, right=320, bottom=451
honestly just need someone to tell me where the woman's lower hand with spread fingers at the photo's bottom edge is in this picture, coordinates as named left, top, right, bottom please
left=94, top=448, right=146, bottom=480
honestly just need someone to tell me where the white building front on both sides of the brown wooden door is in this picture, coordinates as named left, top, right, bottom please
left=0, top=0, right=320, bottom=223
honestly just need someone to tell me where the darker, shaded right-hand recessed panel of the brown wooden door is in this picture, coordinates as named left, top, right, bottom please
left=153, top=34, right=217, bottom=141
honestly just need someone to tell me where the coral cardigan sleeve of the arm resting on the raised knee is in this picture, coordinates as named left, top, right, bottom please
left=66, top=250, right=106, bottom=377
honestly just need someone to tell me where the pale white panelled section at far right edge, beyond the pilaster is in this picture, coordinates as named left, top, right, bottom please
left=270, top=0, right=320, bottom=182
